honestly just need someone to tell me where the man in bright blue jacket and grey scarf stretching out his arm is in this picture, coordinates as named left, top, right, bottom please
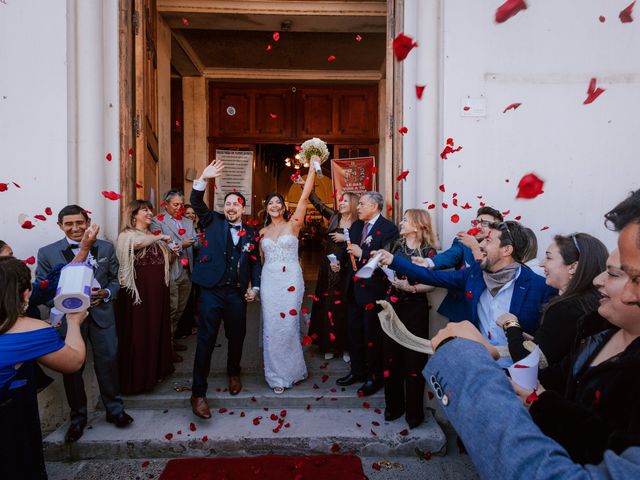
left=381, top=221, right=554, bottom=366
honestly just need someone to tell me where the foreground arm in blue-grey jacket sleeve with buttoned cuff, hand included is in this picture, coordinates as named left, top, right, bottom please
left=423, top=320, right=640, bottom=480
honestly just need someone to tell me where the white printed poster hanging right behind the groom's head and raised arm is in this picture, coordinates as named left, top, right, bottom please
left=214, top=150, right=253, bottom=215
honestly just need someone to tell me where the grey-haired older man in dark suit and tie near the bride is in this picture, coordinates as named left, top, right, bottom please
left=336, top=192, right=399, bottom=396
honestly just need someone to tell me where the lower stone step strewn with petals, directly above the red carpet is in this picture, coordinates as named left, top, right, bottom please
left=44, top=405, right=446, bottom=461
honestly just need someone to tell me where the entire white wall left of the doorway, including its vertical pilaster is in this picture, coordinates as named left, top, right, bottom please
left=0, top=0, right=119, bottom=259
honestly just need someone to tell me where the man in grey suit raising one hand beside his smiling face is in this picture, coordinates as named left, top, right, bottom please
left=36, top=205, right=133, bottom=442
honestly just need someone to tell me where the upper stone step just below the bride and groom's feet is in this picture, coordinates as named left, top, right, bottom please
left=123, top=370, right=384, bottom=410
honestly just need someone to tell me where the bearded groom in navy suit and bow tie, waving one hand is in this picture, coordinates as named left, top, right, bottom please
left=190, top=160, right=262, bottom=418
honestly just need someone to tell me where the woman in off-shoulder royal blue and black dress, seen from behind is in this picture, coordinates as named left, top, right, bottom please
left=0, top=256, right=87, bottom=479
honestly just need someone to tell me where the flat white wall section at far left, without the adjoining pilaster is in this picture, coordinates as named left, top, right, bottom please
left=0, top=0, right=69, bottom=259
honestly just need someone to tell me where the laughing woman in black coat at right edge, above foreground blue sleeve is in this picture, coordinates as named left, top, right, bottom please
left=514, top=250, right=640, bottom=464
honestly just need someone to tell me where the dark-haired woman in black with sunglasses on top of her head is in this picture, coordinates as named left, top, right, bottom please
left=498, top=233, right=608, bottom=365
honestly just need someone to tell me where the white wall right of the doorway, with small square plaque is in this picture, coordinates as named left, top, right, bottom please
left=404, top=0, right=640, bottom=256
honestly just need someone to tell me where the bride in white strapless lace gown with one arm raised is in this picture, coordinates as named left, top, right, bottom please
left=260, top=164, right=315, bottom=394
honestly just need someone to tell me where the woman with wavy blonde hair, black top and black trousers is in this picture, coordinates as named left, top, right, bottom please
left=383, top=208, right=436, bottom=428
